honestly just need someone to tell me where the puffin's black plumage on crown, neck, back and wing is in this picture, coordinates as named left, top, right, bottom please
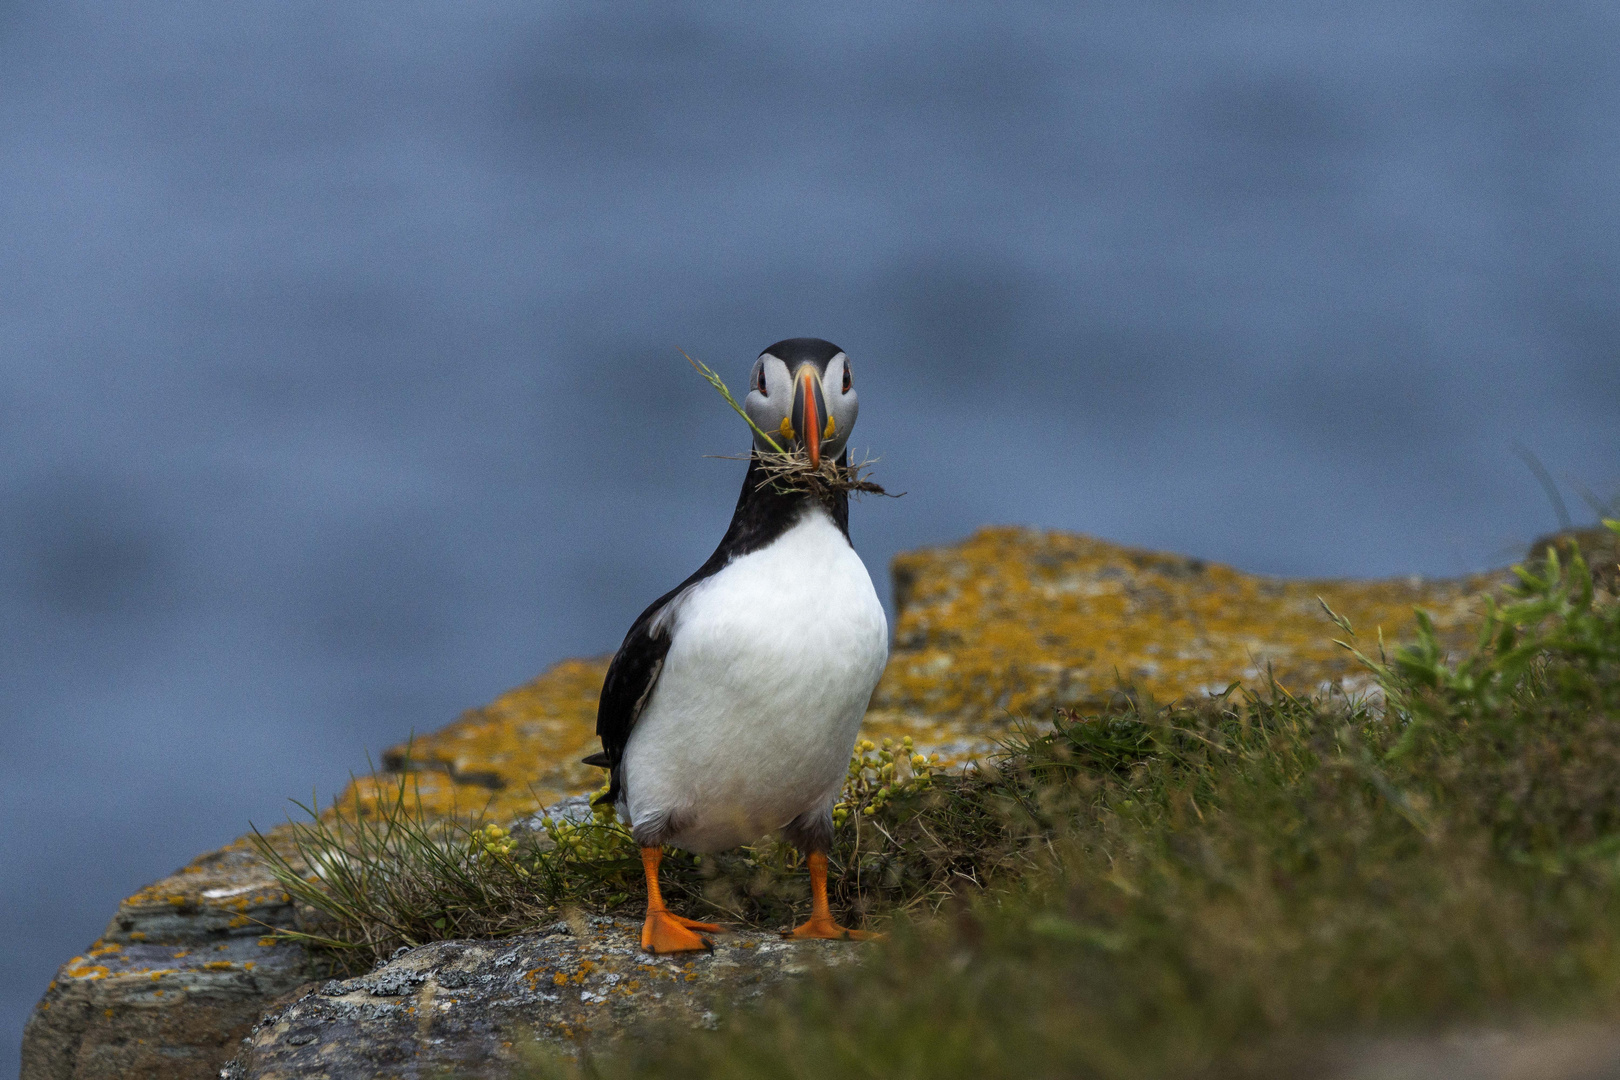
left=585, top=446, right=849, bottom=803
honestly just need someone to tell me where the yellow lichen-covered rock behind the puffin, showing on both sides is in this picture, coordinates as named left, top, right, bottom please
left=345, top=528, right=1500, bottom=819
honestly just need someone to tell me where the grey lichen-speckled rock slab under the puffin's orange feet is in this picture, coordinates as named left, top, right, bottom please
left=222, top=916, right=860, bottom=1080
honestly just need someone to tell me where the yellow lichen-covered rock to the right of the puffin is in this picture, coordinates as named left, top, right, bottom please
left=867, top=528, right=1502, bottom=761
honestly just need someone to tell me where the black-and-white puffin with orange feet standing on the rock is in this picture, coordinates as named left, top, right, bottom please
left=585, top=337, right=889, bottom=954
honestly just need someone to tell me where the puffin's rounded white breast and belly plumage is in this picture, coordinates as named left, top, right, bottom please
left=624, top=508, right=888, bottom=852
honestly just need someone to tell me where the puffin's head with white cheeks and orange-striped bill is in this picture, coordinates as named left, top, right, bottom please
left=742, top=337, right=860, bottom=468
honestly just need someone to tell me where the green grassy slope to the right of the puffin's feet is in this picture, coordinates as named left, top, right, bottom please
left=511, top=525, right=1620, bottom=1080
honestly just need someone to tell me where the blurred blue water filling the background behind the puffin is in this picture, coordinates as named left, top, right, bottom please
left=0, top=0, right=1620, bottom=1046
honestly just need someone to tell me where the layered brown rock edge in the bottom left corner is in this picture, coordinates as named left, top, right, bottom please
left=21, top=842, right=306, bottom=1080
